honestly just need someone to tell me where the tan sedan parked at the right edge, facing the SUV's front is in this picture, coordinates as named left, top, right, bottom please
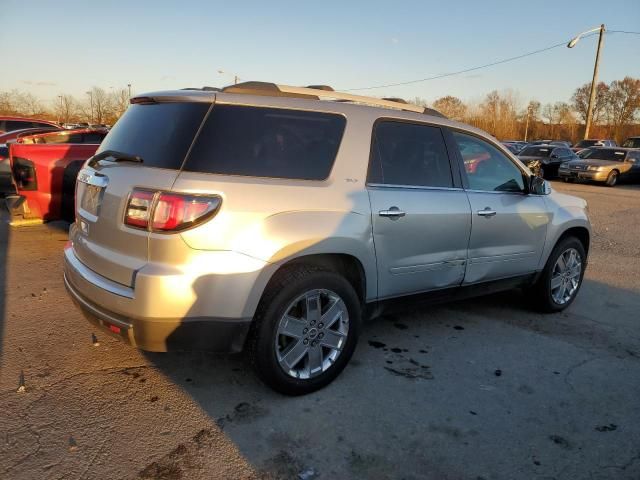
left=558, top=147, right=640, bottom=187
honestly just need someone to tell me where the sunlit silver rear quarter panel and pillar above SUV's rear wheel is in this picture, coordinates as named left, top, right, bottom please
left=170, top=107, right=377, bottom=299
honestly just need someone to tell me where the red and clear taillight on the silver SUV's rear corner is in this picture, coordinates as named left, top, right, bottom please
left=124, top=189, right=221, bottom=232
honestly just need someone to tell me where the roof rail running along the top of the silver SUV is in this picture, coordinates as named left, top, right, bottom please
left=222, top=82, right=444, bottom=117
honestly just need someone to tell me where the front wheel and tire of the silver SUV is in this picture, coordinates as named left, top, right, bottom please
left=530, top=237, right=587, bottom=313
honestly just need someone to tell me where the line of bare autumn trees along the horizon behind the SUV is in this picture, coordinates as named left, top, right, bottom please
left=0, top=77, right=640, bottom=143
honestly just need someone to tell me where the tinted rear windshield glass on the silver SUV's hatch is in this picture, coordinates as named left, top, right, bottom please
left=97, top=102, right=211, bottom=170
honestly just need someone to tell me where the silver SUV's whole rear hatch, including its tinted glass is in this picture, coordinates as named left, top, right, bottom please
left=72, top=94, right=214, bottom=286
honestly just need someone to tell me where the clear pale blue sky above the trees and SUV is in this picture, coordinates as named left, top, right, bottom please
left=0, top=0, right=640, bottom=108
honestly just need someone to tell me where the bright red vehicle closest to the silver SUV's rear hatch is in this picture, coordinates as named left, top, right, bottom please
left=8, top=129, right=108, bottom=222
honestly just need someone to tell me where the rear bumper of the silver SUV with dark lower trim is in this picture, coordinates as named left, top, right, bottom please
left=64, top=244, right=260, bottom=353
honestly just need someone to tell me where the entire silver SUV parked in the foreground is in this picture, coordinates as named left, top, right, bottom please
left=64, top=82, right=590, bottom=395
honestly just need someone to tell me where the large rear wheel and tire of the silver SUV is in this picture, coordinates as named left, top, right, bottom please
left=247, top=266, right=361, bottom=395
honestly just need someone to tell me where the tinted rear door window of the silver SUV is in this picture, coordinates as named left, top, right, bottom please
left=367, top=121, right=453, bottom=188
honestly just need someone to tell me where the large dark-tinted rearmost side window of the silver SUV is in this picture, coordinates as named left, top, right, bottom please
left=184, top=105, right=346, bottom=180
